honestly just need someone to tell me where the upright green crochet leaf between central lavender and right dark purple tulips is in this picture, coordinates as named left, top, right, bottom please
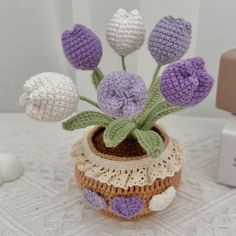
left=135, top=77, right=164, bottom=127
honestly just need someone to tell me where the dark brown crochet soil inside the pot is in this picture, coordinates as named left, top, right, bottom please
left=92, top=128, right=164, bottom=157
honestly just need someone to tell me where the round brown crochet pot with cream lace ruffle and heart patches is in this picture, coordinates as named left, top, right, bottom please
left=72, top=126, right=184, bottom=219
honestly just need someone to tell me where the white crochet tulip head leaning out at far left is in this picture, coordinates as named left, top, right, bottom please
left=20, top=72, right=79, bottom=121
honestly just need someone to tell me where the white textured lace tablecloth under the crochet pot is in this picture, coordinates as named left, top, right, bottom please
left=0, top=114, right=236, bottom=236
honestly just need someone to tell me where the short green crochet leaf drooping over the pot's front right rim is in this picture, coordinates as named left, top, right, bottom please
left=133, top=129, right=164, bottom=158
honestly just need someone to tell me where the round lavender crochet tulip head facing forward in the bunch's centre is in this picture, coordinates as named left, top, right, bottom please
left=97, top=71, right=147, bottom=119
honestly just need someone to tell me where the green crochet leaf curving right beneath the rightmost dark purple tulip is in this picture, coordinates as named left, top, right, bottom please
left=140, top=101, right=183, bottom=130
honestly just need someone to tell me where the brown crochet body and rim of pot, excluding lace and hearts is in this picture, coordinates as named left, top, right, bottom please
left=72, top=126, right=181, bottom=220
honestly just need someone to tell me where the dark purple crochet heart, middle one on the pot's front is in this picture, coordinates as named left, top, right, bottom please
left=111, top=197, right=143, bottom=218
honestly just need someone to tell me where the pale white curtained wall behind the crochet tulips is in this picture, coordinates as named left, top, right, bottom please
left=0, top=0, right=236, bottom=117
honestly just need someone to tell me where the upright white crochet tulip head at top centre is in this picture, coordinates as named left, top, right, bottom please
left=106, top=9, right=145, bottom=56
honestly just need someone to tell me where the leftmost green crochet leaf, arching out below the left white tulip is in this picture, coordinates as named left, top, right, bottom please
left=62, top=111, right=113, bottom=130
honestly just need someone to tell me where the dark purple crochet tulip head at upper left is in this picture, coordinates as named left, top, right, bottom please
left=61, top=25, right=102, bottom=70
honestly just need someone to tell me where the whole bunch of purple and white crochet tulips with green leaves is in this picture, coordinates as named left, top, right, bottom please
left=21, top=9, right=214, bottom=158
